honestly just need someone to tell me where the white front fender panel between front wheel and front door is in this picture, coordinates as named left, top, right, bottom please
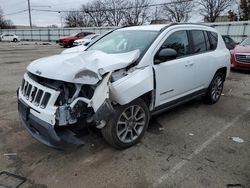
left=110, top=66, right=154, bottom=105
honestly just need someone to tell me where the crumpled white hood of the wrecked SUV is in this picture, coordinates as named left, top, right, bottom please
left=27, top=50, right=140, bottom=85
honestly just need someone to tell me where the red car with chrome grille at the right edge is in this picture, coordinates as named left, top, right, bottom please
left=230, top=37, right=250, bottom=69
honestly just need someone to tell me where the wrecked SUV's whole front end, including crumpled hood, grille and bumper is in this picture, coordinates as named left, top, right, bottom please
left=18, top=51, right=142, bottom=147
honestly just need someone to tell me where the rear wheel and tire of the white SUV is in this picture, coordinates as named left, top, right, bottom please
left=203, top=72, right=225, bottom=104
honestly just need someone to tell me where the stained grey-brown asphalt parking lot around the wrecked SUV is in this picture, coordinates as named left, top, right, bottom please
left=0, top=43, right=250, bottom=188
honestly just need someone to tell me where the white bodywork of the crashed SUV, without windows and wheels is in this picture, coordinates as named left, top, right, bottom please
left=18, top=24, right=230, bottom=147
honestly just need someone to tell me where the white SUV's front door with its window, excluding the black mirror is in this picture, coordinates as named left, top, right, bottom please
left=154, top=30, right=196, bottom=107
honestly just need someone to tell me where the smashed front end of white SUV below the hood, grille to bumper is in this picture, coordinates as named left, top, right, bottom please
left=18, top=70, right=113, bottom=148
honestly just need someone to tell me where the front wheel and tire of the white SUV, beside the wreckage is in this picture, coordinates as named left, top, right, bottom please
left=102, top=99, right=149, bottom=149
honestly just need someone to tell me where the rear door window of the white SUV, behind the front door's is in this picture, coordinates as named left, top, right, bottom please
left=191, top=30, right=207, bottom=54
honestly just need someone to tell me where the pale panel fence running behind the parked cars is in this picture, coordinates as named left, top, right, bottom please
left=0, top=21, right=250, bottom=42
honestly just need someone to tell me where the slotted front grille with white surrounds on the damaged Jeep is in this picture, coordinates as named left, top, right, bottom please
left=21, top=79, right=51, bottom=108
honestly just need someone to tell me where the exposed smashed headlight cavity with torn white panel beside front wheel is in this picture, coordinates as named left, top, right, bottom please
left=56, top=73, right=114, bottom=127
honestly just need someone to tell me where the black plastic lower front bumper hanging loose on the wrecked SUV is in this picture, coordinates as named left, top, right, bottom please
left=18, top=99, right=64, bottom=148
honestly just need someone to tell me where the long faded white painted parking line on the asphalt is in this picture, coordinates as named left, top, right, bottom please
left=153, top=109, right=250, bottom=187
